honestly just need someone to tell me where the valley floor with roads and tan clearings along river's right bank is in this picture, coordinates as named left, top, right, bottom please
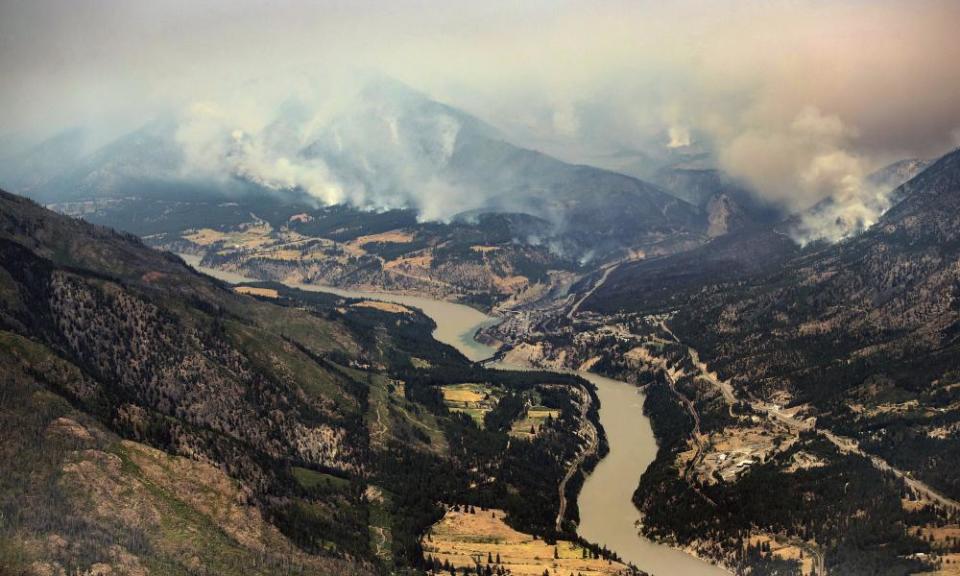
left=485, top=269, right=960, bottom=576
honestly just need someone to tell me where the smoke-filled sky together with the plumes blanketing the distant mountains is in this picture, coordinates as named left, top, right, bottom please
left=0, top=0, right=960, bottom=244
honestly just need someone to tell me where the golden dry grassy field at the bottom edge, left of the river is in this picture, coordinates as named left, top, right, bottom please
left=423, top=508, right=627, bottom=576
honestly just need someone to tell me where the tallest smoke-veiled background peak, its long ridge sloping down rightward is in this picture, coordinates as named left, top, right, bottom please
left=296, top=82, right=698, bottom=251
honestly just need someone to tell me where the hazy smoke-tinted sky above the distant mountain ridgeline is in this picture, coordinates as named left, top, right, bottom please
left=0, top=0, right=960, bottom=223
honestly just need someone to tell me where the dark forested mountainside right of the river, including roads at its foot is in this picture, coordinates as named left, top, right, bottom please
left=487, top=150, right=960, bottom=576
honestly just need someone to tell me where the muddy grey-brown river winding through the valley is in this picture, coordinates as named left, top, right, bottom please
left=180, top=254, right=729, bottom=576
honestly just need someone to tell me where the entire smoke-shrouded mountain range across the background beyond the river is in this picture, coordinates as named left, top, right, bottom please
left=12, top=80, right=702, bottom=253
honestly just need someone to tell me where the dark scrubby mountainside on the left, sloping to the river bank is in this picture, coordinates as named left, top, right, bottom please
left=0, top=192, right=610, bottom=575
